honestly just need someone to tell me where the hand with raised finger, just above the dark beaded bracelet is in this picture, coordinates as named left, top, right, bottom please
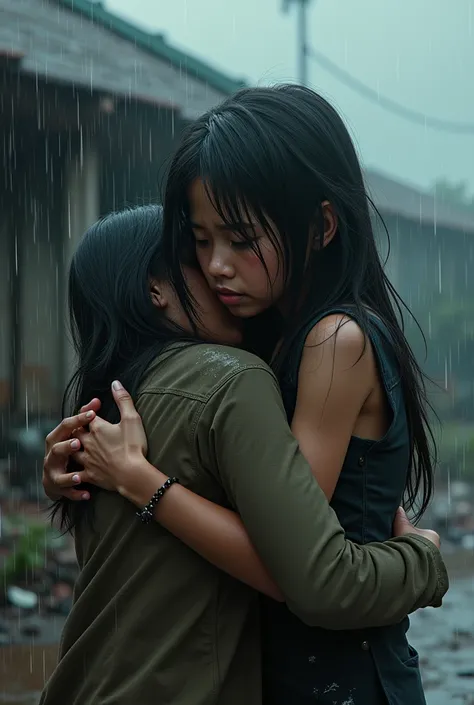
left=73, top=382, right=147, bottom=492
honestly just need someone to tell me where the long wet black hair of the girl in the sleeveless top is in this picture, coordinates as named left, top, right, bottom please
left=164, top=85, right=436, bottom=520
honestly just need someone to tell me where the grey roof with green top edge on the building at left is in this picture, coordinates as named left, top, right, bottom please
left=0, top=0, right=242, bottom=119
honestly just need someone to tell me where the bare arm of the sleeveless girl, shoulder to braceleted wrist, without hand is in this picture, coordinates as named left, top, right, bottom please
left=43, top=317, right=372, bottom=601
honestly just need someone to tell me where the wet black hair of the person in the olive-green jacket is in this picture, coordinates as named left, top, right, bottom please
left=52, top=205, right=197, bottom=531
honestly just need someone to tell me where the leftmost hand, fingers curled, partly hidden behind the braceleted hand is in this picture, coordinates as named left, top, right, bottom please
left=43, top=399, right=100, bottom=501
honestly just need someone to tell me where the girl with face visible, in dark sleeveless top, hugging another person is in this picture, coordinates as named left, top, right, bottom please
left=46, top=86, right=434, bottom=705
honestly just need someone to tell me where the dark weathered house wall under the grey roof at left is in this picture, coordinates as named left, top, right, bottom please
left=0, top=107, right=179, bottom=416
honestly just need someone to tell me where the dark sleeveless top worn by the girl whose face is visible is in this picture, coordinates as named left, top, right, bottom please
left=261, top=306, right=426, bottom=705
